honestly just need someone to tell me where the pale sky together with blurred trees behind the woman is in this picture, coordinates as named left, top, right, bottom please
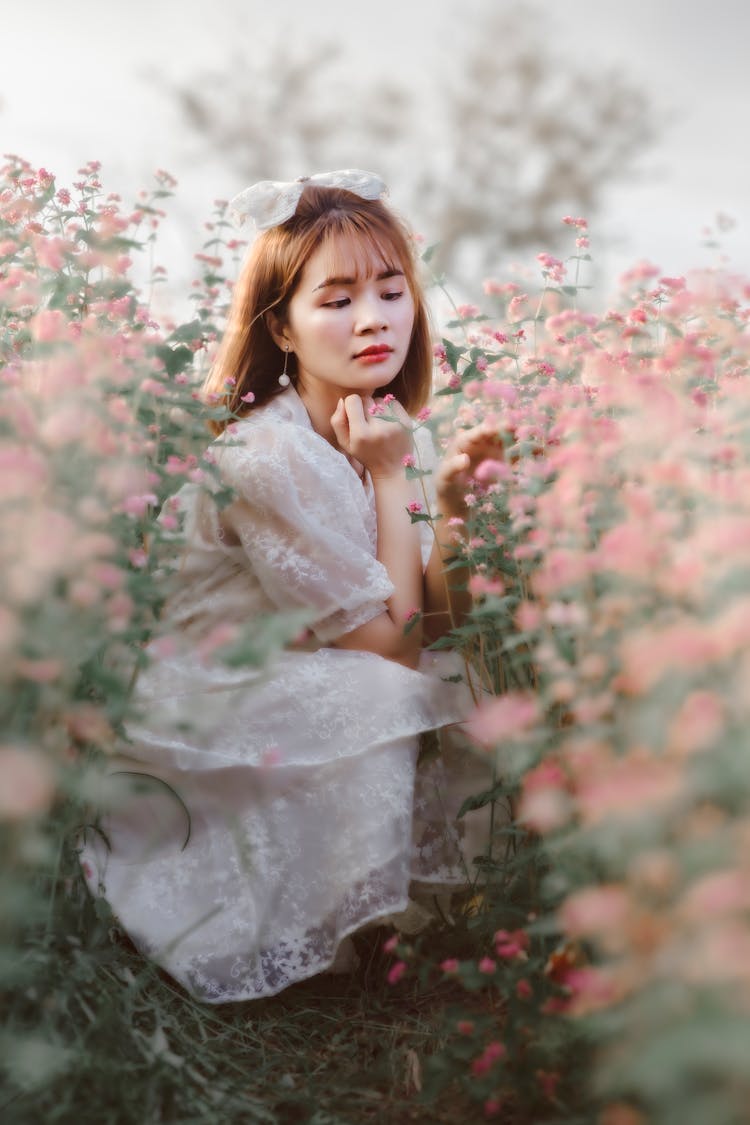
left=0, top=0, right=750, bottom=306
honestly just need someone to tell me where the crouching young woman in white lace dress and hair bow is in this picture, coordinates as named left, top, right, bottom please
left=83, top=172, right=497, bottom=1002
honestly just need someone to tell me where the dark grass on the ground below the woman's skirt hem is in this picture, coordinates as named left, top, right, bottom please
left=0, top=856, right=488, bottom=1125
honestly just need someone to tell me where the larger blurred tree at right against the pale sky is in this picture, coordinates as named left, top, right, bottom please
left=421, top=8, right=654, bottom=283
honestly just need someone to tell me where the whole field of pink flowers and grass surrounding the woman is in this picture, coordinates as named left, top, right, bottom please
left=0, top=159, right=750, bottom=1125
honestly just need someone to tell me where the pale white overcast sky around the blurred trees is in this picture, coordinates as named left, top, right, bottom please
left=0, top=0, right=750, bottom=308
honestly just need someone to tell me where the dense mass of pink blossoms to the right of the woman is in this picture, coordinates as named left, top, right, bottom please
left=427, top=217, right=750, bottom=1118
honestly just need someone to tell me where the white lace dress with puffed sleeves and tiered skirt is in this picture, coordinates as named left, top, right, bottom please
left=82, top=387, right=474, bottom=1002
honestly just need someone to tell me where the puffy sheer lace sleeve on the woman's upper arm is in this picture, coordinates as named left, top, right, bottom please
left=217, top=424, right=394, bottom=644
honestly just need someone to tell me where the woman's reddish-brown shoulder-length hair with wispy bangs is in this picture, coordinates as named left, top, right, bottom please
left=204, top=185, right=433, bottom=434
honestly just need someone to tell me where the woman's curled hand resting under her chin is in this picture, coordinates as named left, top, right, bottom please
left=331, top=395, right=413, bottom=480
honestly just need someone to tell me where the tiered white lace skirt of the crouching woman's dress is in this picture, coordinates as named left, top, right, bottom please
left=81, top=648, right=484, bottom=1002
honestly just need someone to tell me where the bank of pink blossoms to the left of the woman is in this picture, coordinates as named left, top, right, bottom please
left=0, top=158, right=231, bottom=825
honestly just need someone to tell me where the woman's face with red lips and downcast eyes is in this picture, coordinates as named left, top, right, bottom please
left=275, top=240, right=414, bottom=412
